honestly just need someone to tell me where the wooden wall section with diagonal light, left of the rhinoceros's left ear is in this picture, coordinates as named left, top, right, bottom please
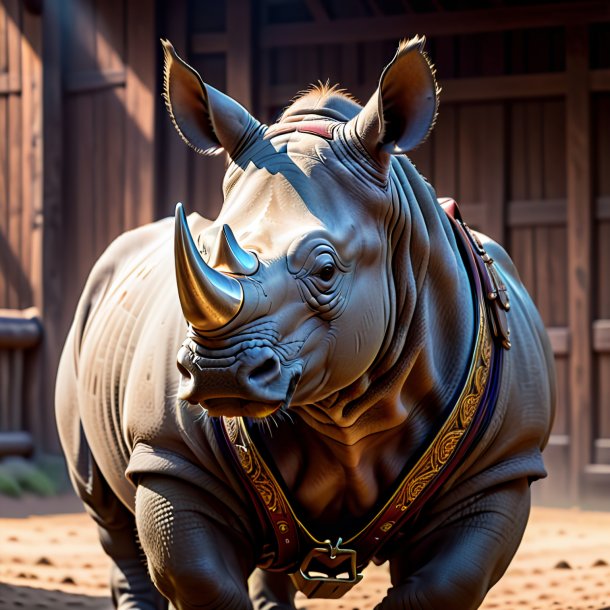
left=41, top=0, right=158, bottom=450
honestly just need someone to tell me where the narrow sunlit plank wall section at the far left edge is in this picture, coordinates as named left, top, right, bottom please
left=0, top=0, right=42, bottom=449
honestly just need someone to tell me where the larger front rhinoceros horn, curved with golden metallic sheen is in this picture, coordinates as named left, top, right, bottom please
left=174, top=203, right=244, bottom=334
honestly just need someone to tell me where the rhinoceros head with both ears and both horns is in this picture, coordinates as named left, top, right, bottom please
left=163, top=38, right=437, bottom=424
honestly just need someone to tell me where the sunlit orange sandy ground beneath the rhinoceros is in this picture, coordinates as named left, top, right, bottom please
left=0, top=496, right=610, bottom=610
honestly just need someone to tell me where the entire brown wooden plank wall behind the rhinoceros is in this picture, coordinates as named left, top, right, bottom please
left=0, top=0, right=610, bottom=504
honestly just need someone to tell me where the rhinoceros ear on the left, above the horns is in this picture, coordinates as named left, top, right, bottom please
left=161, top=40, right=258, bottom=155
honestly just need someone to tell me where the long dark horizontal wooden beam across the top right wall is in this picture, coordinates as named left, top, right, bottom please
left=260, top=0, right=610, bottom=48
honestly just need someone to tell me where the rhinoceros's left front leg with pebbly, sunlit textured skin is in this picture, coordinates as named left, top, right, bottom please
left=136, top=475, right=253, bottom=610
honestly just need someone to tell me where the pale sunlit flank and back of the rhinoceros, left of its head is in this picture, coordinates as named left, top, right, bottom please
left=56, top=219, right=191, bottom=508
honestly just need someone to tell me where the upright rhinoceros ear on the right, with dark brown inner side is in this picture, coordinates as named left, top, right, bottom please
left=350, top=36, right=439, bottom=157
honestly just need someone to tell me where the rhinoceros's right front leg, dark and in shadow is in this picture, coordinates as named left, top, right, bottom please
left=376, top=479, right=530, bottom=610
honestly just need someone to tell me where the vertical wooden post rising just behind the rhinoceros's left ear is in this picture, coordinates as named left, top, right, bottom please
left=226, top=0, right=252, bottom=109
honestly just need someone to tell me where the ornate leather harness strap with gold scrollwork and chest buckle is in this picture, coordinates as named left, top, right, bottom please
left=214, top=199, right=510, bottom=598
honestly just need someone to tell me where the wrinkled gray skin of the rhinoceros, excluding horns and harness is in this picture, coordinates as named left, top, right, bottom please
left=57, top=40, right=554, bottom=610
